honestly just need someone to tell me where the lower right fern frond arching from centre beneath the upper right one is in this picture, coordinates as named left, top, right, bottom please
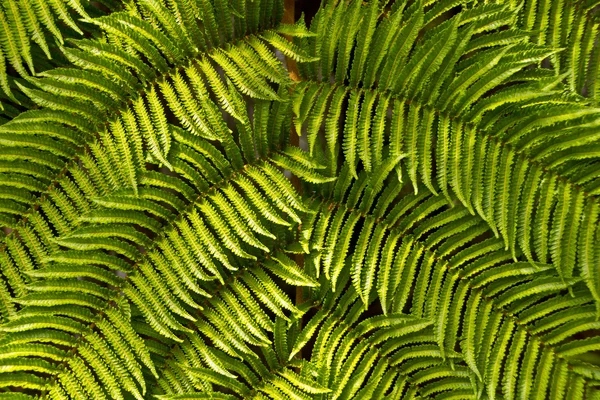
left=303, top=170, right=600, bottom=398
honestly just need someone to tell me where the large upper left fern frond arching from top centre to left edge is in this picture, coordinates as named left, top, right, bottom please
left=0, top=3, right=312, bottom=316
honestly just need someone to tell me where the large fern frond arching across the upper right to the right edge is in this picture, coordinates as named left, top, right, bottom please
left=296, top=3, right=597, bottom=310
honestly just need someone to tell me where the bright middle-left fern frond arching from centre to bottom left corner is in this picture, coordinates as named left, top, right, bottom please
left=1, top=85, right=332, bottom=398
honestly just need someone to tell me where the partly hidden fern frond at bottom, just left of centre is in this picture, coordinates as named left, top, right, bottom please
left=149, top=249, right=329, bottom=398
